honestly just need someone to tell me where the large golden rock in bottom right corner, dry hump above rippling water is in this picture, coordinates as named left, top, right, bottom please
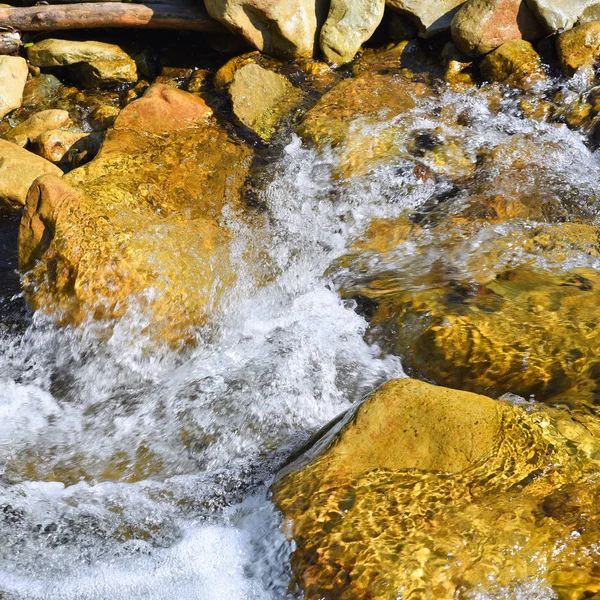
left=273, top=379, right=600, bottom=600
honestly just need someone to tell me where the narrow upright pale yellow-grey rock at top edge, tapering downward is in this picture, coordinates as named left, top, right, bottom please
left=320, top=0, right=385, bottom=64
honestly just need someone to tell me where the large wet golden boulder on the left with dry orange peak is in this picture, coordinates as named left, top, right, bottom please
left=19, top=85, right=251, bottom=341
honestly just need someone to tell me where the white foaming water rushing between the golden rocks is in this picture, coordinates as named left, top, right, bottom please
left=0, top=82, right=600, bottom=600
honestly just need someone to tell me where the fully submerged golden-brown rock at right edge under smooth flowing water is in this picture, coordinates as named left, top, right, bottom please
left=345, top=221, right=600, bottom=410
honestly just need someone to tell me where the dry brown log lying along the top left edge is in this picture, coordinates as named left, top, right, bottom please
left=0, top=2, right=225, bottom=33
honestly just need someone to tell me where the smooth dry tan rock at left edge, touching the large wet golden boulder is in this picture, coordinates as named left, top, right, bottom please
left=0, top=140, right=62, bottom=207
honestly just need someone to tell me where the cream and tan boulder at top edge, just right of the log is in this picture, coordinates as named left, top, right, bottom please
left=205, top=0, right=329, bottom=58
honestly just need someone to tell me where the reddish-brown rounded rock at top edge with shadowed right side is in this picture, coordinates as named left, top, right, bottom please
left=452, top=0, right=545, bottom=55
